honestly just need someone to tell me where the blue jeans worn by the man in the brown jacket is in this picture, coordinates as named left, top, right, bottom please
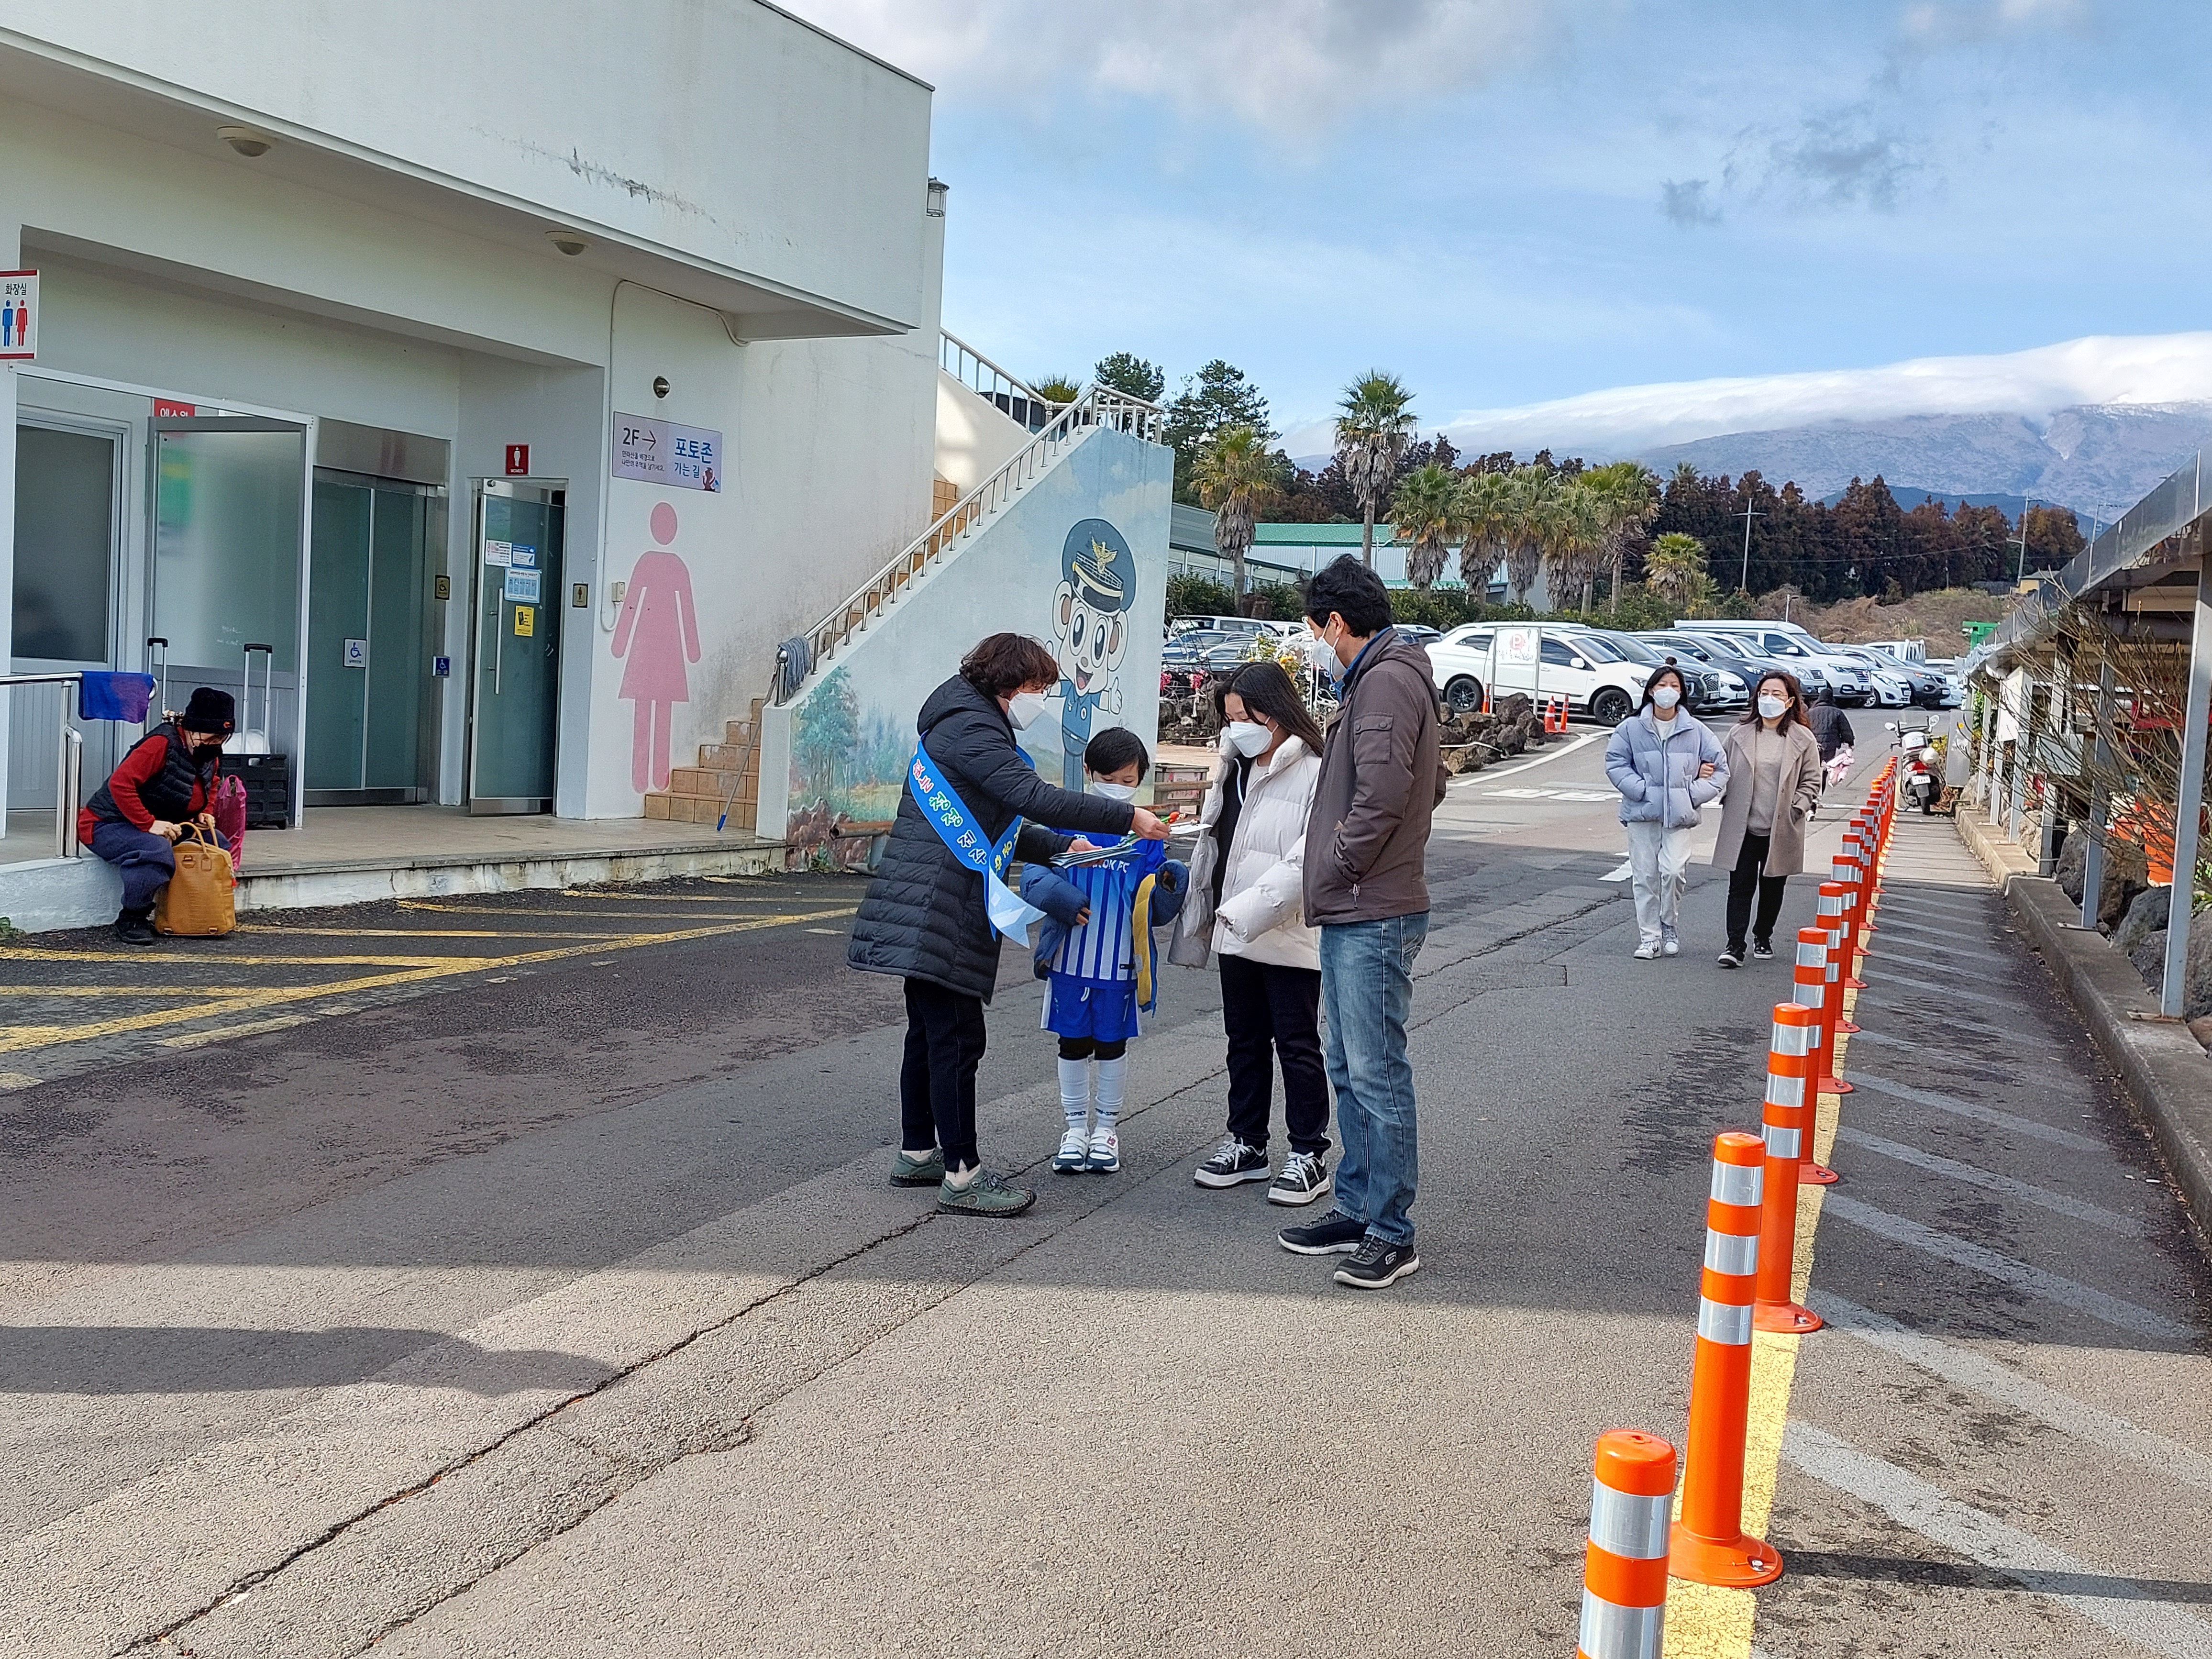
left=1321, top=911, right=1429, bottom=1245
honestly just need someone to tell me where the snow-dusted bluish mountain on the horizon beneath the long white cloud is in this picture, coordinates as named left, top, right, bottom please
left=1626, top=400, right=2212, bottom=522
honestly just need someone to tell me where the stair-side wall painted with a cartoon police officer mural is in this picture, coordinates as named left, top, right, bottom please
left=761, top=418, right=1172, bottom=867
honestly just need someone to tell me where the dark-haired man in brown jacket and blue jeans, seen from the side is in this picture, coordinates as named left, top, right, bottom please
left=1276, top=555, right=1444, bottom=1290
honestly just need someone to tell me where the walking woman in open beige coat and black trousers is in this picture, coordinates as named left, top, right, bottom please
left=1712, top=668, right=1821, bottom=967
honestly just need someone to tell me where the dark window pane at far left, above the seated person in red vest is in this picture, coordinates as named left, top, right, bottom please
left=11, top=427, right=115, bottom=664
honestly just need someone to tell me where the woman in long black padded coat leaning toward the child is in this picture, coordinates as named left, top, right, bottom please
left=845, top=632, right=1168, bottom=1217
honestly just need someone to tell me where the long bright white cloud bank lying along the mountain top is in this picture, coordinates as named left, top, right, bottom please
left=1380, top=332, right=2212, bottom=456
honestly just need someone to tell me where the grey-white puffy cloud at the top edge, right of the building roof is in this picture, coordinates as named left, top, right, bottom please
left=787, top=0, right=1575, bottom=135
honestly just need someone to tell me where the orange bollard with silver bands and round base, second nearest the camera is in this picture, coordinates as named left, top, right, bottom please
left=1668, top=1130, right=1783, bottom=1586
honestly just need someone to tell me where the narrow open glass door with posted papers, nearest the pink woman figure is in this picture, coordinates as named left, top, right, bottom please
left=469, top=478, right=566, bottom=812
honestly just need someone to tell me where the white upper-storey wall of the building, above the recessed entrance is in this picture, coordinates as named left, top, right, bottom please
left=0, top=0, right=933, bottom=327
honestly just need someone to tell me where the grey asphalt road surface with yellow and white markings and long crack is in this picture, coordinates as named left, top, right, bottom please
left=0, top=732, right=2212, bottom=1659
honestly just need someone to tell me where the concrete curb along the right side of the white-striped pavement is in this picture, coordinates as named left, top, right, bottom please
left=1958, top=814, right=2212, bottom=1256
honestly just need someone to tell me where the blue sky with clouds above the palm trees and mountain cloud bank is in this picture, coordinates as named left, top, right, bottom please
left=792, top=0, right=2212, bottom=449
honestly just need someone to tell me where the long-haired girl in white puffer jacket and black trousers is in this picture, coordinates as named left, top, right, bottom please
left=1168, top=662, right=1329, bottom=1203
